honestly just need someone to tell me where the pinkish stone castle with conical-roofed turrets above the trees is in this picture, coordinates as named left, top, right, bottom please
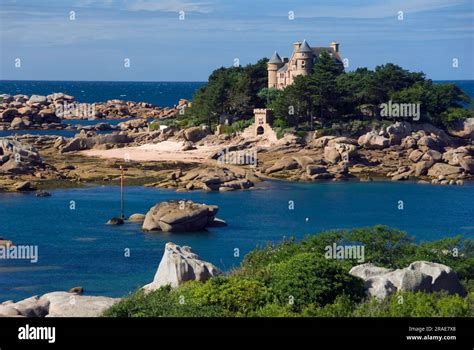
left=267, top=40, right=343, bottom=90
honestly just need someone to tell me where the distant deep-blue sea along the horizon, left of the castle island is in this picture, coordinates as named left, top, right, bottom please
left=0, top=80, right=205, bottom=107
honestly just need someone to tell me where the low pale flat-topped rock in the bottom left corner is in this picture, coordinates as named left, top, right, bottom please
left=0, top=292, right=120, bottom=317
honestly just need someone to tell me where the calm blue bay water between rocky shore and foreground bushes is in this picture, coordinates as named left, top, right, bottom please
left=0, top=181, right=474, bottom=301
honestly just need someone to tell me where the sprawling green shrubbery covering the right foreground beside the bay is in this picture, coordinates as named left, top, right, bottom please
left=105, top=226, right=474, bottom=317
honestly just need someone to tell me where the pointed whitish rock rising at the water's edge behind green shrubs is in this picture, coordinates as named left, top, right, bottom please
left=143, top=242, right=222, bottom=292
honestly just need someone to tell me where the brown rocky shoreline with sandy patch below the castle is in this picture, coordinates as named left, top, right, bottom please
left=0, top=93, right=474, bottom=192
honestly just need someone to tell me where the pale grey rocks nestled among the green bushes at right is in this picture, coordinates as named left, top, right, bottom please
left=349, top=261, right=466, bottom=299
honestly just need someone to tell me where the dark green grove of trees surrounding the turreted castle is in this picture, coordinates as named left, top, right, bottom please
left=178, top=52, right=474, bottom=133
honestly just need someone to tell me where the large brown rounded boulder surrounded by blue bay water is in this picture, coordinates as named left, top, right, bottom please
left=142, top=200, right=219, bottom=232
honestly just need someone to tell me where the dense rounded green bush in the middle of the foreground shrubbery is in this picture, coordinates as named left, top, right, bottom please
left=267, top=253, right=365, bottom=310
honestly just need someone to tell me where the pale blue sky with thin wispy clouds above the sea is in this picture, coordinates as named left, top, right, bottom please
left=0, top=0, right=474, bottom=81
